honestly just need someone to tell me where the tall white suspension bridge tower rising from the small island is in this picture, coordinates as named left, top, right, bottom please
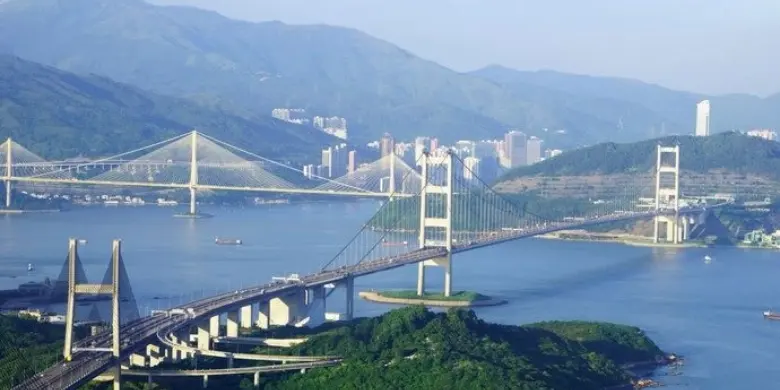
left=417, top=150, right=455, bottom=297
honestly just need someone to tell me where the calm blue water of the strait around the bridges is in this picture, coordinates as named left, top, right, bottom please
left=0, top=201, right=780, bottom=389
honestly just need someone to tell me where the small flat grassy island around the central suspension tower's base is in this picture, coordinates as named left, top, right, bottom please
left=358, top=290, right=506, bottom=307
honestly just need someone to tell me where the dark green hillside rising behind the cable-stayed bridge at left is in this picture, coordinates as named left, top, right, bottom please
left=0, top=55, right=336, bottom=161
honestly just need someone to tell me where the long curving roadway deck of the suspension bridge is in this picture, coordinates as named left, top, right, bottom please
left=14, top=203, right=725, bottom=390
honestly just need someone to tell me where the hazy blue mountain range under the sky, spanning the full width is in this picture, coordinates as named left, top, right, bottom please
left=0, top=0, right=780, bottom=147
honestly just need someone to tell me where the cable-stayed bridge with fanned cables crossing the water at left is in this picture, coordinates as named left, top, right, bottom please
left=0, top=131, right=421, bottom=214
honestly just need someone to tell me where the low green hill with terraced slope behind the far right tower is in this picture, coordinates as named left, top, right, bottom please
left=500, top=132, right=780, bottom=181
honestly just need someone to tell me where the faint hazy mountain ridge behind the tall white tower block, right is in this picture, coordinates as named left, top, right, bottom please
left=471, top=65, right=780, bottom=141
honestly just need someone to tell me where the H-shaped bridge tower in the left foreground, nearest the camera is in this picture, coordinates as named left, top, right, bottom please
left=62, top=238, right=122, bottom=390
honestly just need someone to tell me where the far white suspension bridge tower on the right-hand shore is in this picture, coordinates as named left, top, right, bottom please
left=653, top=145, right=688, bottom=244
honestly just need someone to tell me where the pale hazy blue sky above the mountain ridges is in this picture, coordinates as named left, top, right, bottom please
left=151, top=0, right=780, bottom=95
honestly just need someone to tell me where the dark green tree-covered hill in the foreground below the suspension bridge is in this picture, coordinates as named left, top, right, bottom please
left=102, top=306, right=663, bottom=390
